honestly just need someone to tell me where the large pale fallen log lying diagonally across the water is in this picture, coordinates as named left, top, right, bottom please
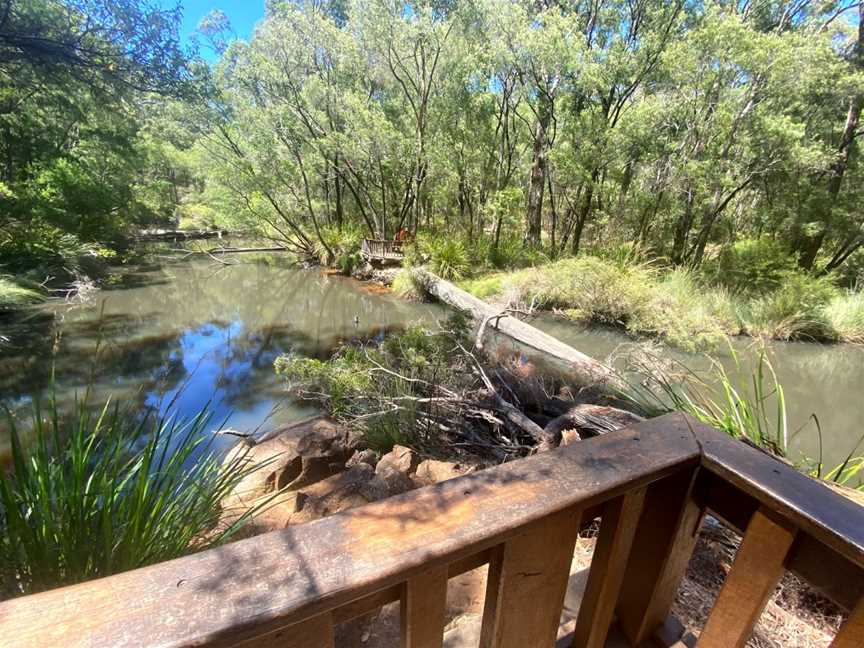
left=411, top=268, right=622, bottom=392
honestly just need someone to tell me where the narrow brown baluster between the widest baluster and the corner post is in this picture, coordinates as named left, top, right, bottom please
left=573, top=488, right=645, bottom=648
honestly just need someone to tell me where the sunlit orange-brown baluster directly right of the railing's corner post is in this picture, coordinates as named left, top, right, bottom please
left=699, top=509, right=795, bottom=648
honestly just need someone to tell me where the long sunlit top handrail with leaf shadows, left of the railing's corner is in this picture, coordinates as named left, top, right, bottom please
left=0, top=415, right=699, bottom=648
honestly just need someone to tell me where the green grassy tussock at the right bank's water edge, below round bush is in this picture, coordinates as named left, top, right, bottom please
left=747, top=272, right=838, bottom=340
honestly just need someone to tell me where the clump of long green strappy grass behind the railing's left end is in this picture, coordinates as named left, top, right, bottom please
left=0, top=398, right=272, bottom=595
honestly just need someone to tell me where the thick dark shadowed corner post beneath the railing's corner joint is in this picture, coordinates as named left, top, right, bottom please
left=617, top=470, right=702, bottom=646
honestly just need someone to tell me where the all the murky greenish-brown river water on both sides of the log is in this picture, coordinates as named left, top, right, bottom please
left=0, top=255, right=864, bottom=476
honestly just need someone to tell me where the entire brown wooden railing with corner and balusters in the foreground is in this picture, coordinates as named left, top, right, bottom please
left=0, top=414, right=864, bottom=648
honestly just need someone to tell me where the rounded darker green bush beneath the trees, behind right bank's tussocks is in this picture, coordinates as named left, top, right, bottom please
left=704, top=238, right=795, bottom=294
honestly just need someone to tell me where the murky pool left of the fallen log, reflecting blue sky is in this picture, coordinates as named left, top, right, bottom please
left=0, top=258, right=442, bottom=458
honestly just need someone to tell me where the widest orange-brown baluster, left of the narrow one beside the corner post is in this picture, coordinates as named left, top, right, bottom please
left=480, top=511, right=580, bottom=648
